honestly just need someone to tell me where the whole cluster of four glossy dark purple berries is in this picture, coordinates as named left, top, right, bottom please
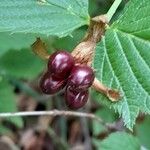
left=40, top=51, right=95, bottom=109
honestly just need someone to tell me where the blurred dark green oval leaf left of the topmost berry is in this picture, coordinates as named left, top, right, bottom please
left=0, top=49, right=45, bottom=79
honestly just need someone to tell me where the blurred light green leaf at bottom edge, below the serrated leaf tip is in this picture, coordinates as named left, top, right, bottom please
left=93, top=132, right=141, bottom=150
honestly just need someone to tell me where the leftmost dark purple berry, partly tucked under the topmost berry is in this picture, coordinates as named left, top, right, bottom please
left=40, top=72, right=66, bottom=94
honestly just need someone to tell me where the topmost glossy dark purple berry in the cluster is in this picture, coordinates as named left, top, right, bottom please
left=48, top=51, right=75, bottom=79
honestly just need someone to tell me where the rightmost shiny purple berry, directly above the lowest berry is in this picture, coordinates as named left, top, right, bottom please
left=67, top=65, right=95, bottom=91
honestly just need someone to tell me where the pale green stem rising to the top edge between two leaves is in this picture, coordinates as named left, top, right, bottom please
left=106, top=0, right=122, bottom=22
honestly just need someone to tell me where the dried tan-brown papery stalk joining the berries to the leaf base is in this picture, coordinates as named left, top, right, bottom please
left=72, top=15, right=106, bottom=66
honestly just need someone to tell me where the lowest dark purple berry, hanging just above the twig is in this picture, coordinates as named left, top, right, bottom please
left=65, top=87, right=89, bottom=109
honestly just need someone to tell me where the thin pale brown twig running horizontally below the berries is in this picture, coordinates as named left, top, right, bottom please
left=0, top=109, right=105, bottom=124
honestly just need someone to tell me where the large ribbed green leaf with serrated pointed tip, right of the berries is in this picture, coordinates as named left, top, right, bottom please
left=94, top=0, right=150, bottom=130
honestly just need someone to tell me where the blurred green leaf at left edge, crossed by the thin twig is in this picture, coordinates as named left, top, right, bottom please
left=0, top=79, right=23, bottom=127
